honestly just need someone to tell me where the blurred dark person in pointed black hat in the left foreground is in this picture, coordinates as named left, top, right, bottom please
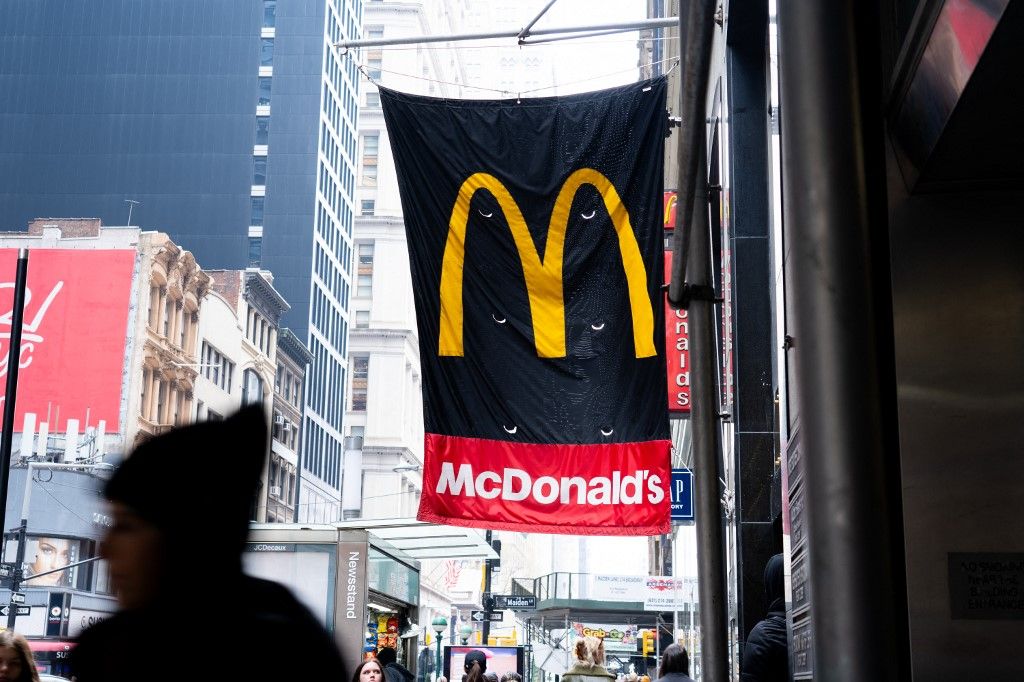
left=71, top=406, right=347, bottom=682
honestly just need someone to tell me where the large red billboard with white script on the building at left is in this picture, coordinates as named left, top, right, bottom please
left=0, top=249, right=135, bottom=433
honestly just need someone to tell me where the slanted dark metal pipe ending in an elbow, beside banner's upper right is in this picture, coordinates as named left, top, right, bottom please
left=669, top=0, right=715, bottom=308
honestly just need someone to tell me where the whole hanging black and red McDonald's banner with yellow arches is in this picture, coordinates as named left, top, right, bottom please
left=381, top=78, right=671, bottom=535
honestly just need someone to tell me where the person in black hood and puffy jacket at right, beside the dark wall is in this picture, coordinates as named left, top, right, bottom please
left=739, top=554, right=790, bottom=682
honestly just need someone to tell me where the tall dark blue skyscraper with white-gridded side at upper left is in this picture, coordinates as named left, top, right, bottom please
left=0, top=0, right=362, bottom=521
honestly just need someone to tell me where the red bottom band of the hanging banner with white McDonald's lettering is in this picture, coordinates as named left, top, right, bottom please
left=417, top=433, right=671, bottom=536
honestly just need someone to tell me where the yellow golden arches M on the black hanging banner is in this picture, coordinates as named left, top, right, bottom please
left=438, top=168, right=657, bottom=357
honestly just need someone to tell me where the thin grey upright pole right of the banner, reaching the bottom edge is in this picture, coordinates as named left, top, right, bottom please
left=686, top=140, right=729, bottom=682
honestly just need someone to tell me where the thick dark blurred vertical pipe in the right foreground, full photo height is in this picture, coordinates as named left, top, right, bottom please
left=778, top=0, right=907, bottom=682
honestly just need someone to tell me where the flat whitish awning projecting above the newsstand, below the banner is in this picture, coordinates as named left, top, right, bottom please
left=335, top=518, right=498, bottom=559
